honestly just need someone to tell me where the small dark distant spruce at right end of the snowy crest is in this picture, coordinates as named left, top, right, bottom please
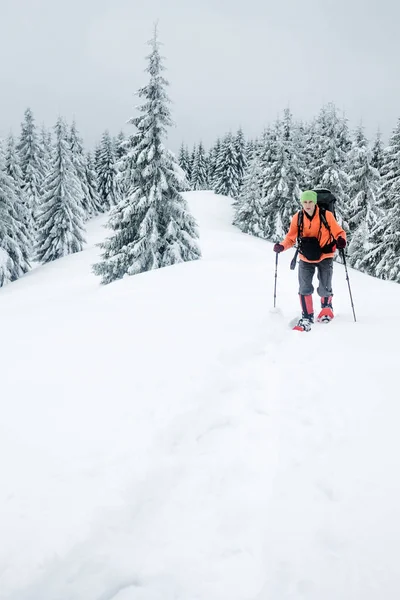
left=214, top=133, right=240, bottom=200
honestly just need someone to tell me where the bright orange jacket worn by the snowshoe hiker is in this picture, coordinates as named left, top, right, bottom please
left=281, top=205, right=346, bottom=263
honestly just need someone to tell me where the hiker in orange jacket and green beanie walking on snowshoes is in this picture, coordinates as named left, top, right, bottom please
left=274, top=190, right=346, bottom=331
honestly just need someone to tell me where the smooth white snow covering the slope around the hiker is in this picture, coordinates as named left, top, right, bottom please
left=0, top=192, right=400, bottom=600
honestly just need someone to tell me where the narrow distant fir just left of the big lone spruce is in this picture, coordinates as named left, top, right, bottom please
left=96, top=131, right=120, bottom=211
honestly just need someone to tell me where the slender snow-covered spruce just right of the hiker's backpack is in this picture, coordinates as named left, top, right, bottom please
left=348, top=126, right=382, bottom=269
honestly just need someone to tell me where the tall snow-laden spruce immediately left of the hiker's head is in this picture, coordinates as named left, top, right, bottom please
left=264, top=109, right=304, bottom=241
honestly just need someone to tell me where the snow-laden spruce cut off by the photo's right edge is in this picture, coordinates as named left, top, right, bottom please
left=359, top=119, right=400, bottom=283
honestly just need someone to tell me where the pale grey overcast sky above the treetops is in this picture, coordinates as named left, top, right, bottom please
left=0, top=0, right=400, bottom=150
